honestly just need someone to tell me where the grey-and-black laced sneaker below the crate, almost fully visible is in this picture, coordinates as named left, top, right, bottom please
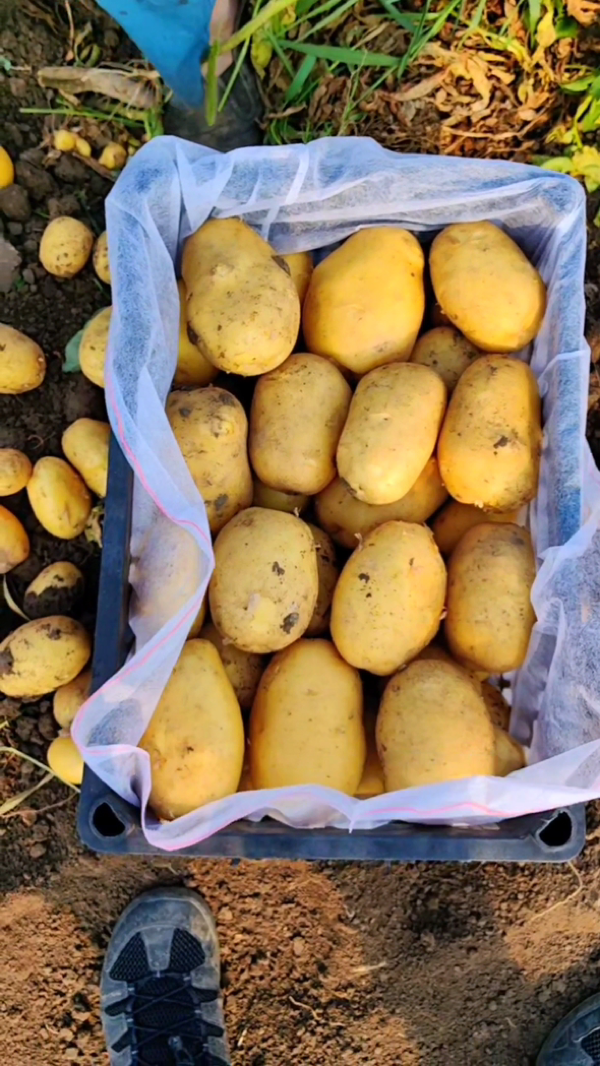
left=100, top=888, right=230, bottom=1066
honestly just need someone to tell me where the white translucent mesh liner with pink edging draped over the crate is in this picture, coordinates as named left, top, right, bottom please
left=74, top=138, right=600, bottom=851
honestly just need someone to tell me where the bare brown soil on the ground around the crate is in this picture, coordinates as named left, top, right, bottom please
left=0, top=0, right=600, bottom=1066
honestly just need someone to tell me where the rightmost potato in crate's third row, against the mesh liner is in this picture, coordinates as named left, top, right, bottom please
left=444, top=522, right=535, bottom=674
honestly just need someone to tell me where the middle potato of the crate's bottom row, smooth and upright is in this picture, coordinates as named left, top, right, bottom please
left=249, top=640, right=367, bottom=795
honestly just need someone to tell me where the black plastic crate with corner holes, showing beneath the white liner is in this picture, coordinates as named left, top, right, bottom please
left=78, top=437, right=585, bottom=862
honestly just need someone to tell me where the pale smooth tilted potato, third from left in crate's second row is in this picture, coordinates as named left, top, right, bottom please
left=337, top=362, right=445, bottom=505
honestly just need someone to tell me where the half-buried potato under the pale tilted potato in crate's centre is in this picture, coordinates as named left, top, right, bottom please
left=314, top=455, right=448, bottom=551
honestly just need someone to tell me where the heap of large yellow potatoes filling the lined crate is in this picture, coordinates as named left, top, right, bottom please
left=124, top=212, right=546, bottom=819
